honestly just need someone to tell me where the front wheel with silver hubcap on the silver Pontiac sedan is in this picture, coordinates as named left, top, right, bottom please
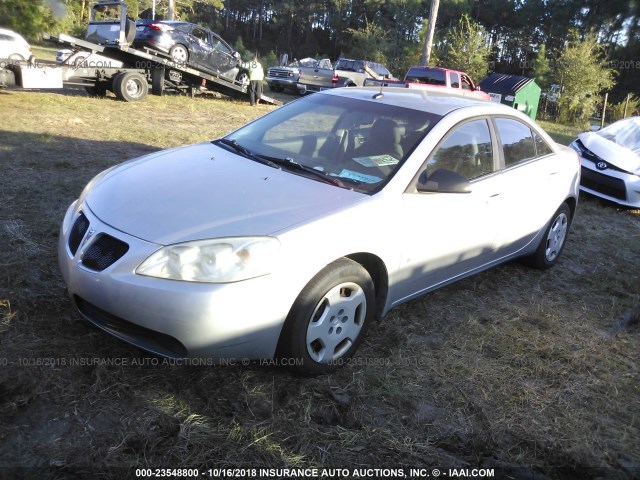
left=278, top=258, right=376, bottom=374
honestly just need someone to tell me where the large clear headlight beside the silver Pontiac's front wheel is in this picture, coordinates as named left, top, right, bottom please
left=136, top=237, right=280, bottom=283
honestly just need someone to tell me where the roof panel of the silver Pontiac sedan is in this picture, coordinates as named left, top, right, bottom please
left=316, top=87, right=513, bottom=116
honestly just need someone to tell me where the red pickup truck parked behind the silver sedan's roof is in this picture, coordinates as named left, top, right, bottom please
left=364, top=66, right=491, bottom=100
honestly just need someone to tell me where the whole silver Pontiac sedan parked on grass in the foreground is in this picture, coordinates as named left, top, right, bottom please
left=59, top=88, right=580, bottom=373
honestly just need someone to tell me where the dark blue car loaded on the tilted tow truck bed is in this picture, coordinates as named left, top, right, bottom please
left=133, top=20, right=249, bottom=83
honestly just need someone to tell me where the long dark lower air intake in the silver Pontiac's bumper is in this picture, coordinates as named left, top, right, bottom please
left=73, top=295, right=187, bottom=358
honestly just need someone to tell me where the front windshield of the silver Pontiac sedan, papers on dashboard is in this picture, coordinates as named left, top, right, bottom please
left=226, top=94, right=440, bottom=193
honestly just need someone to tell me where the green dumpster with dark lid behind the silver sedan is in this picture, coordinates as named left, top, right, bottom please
left=480, top=73, right=540, bottom=120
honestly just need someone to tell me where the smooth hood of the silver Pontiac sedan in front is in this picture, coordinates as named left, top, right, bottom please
left=83, top=143, right=367, bottom=245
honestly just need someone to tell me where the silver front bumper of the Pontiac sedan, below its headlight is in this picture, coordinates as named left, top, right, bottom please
left=58, top=202, right=291, bottom=361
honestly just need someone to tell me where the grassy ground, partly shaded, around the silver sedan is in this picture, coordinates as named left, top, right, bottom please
left=0, top=90, right=640, bottom=480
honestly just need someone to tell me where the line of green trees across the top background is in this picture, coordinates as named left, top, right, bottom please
left=0, top=0, right=640, bottom=120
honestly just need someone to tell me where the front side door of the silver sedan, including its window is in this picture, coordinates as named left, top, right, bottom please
left=394, top=119, right=502, bottom=303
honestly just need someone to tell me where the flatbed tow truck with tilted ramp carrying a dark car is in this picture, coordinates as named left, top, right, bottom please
left=0, top=1, right=281, bottom=105
